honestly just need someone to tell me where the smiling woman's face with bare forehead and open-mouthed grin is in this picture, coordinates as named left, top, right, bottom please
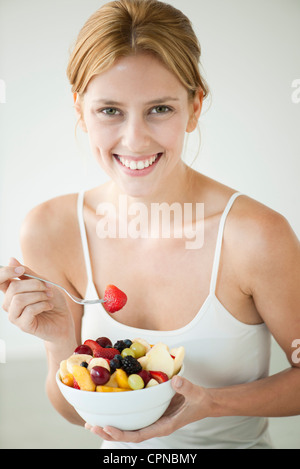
left=81, top=55, right=201, bottom=197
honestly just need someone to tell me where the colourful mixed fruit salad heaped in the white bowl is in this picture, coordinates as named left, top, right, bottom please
left=59, top=337, right=184, bottom=392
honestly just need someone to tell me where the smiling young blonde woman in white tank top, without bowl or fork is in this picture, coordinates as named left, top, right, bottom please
left=0, top=0, right=300, bottom=449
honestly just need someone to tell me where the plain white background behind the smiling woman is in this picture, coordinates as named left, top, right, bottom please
left=0, top=0, right=300, bottom=448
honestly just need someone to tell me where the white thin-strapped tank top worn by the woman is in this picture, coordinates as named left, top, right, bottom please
left=78, top=192, right=272, bottom=449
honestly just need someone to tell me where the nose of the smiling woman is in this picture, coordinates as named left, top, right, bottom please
left=122, top=115, right=151, bottom=153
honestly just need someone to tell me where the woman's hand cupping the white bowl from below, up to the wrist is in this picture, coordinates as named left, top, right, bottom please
left=85, top=376, right=212, bottom=443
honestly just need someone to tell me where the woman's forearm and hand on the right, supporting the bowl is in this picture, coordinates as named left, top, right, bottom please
left=85, top=368, right=300, bottom=443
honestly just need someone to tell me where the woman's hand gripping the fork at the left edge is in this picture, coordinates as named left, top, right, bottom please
left=0, top=259, right=74, bottom=342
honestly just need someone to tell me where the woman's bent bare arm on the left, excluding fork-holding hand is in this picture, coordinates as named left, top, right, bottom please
left=21, top=197, right=84, bottom=425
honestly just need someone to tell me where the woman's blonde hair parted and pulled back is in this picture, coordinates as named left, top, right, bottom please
left=67, top=0, right=209, bottom=98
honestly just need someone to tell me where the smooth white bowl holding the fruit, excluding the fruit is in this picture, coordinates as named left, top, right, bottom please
left=56, top=367, right=183, bottom=430
